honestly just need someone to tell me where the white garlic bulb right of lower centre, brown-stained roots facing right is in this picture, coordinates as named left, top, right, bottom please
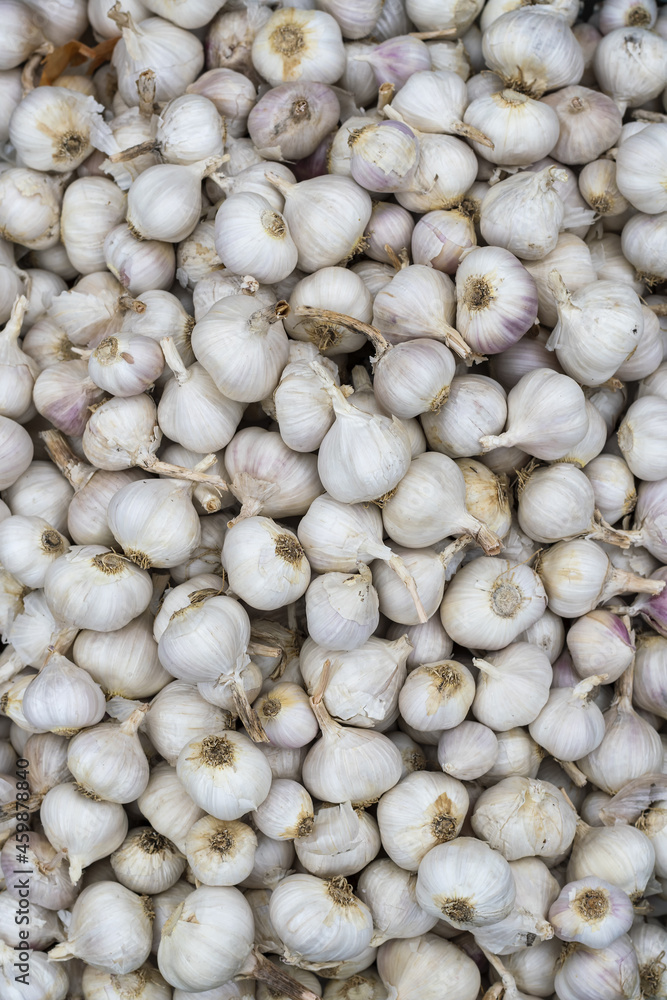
left=377, top=771, right=468, bottom=872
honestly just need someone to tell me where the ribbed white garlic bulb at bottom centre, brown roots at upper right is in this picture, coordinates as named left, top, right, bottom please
left=269, top=875, right=373, bottom=962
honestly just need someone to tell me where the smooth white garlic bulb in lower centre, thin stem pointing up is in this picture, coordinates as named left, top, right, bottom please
left=302, top=699, right=402, bottom=803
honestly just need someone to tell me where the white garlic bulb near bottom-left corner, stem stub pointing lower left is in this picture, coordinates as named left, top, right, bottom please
left=49, top=882, right=152, bottom=975
